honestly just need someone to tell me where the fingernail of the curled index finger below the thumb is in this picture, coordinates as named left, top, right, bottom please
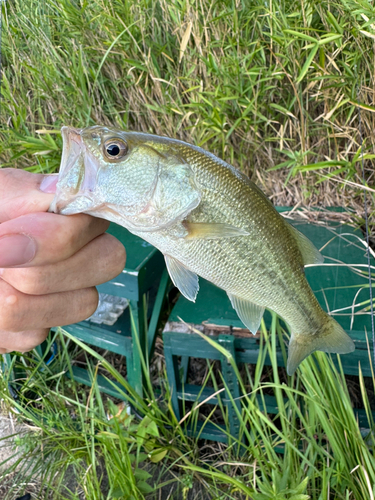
left=0, top=234, right=36, bottom=267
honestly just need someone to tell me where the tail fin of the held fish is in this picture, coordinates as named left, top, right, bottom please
left=286, top=314, right=355, bottom=375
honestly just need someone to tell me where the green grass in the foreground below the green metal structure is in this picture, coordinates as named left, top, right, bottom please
left=0, top=317, right=375, bottom=500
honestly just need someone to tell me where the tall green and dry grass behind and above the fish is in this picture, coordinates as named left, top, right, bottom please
left=0, top=0, right=375, bottom=208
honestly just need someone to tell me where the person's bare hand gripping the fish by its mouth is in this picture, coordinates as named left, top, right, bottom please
left=0, top=168, right=126, bottom=354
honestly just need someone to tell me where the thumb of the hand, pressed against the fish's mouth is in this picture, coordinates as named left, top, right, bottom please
left=0, top=168, right=58, bottom=224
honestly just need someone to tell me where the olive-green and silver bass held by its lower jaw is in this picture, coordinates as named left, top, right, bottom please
left=49, top=125, right=354, bottom=375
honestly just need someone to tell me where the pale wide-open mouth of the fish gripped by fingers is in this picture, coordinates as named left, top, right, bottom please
left=49, top=127, right=98, bottom=215
